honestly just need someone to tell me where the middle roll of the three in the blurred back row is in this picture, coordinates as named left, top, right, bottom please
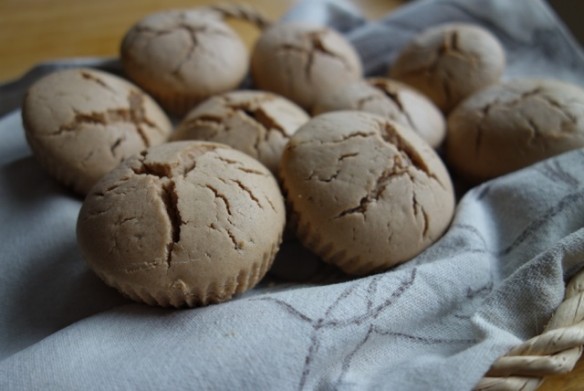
left=251, top=22, right=363, bottom=112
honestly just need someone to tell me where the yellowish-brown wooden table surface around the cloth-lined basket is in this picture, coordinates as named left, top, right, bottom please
left=0, top=0, right=584, bottom=391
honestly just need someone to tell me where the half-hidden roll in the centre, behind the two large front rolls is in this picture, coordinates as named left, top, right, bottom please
left=171, top=91, right=310, bottom=175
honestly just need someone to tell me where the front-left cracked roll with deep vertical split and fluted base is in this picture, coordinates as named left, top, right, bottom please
left=77, top=141, right=285, bottom=307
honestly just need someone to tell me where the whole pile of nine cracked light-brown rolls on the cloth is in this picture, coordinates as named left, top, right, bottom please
left=17, top=7, right=584, bottom=307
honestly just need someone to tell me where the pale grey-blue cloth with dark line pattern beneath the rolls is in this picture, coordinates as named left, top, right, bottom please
left=0, top=0, right=584, bottom=391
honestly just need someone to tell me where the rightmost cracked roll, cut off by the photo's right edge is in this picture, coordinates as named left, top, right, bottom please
left=445, top=79, right=584, bottom=182
